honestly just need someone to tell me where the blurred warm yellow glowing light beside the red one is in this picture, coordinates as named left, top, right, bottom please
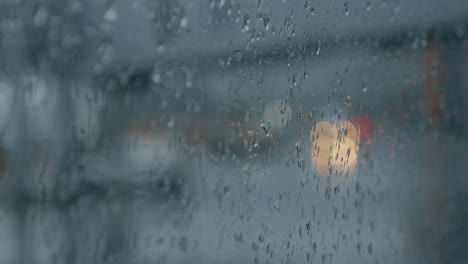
left=310, top=121, right=359, bottom=175
